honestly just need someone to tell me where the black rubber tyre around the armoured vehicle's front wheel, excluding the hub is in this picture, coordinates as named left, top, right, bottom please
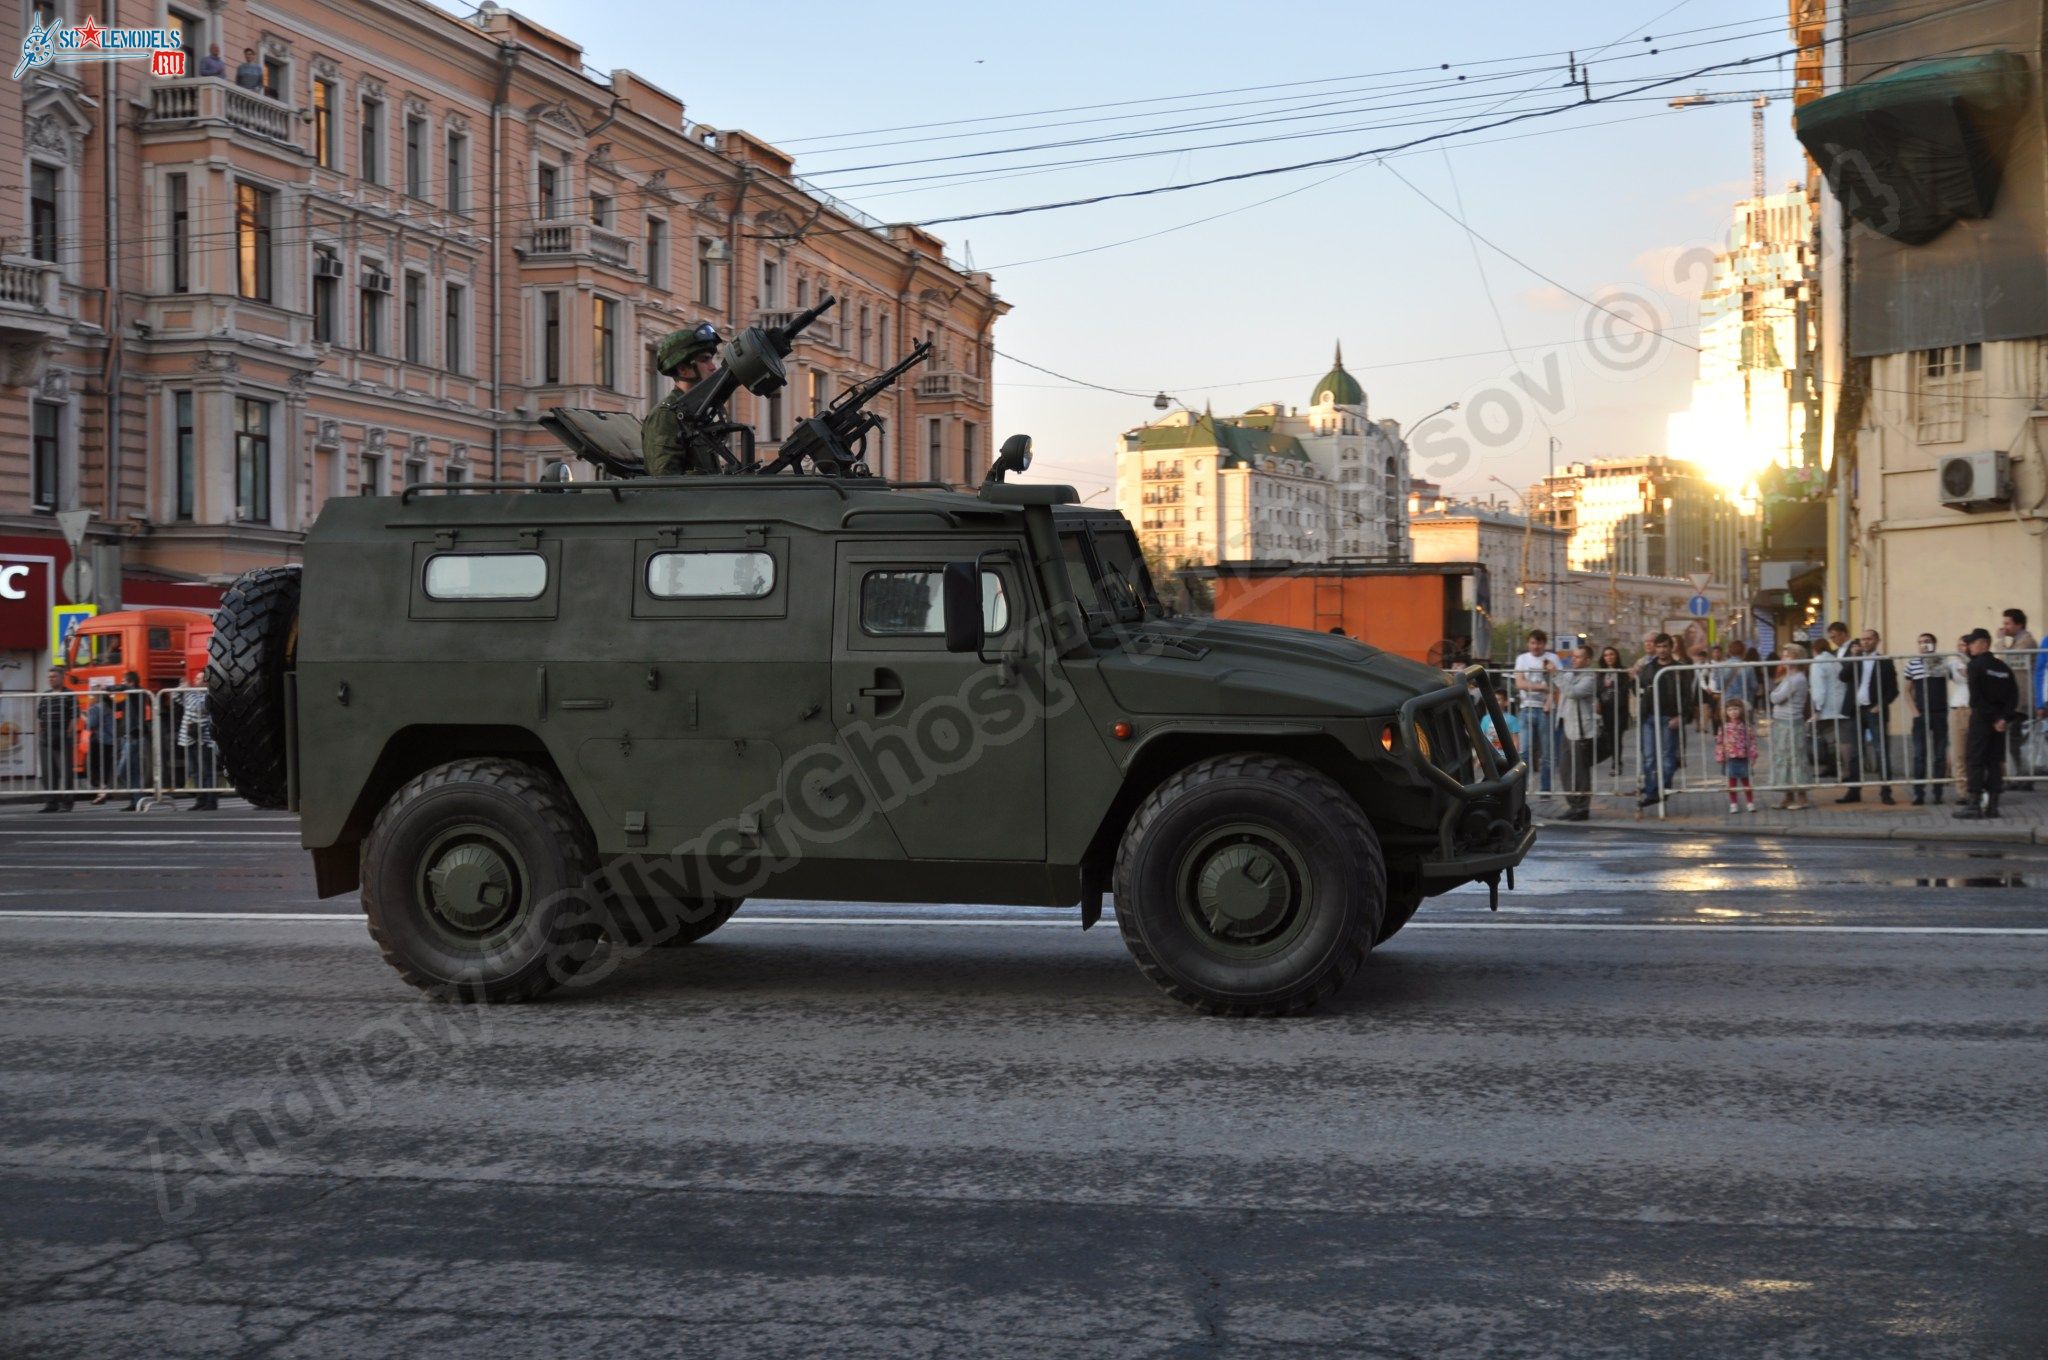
left=1114, top=752, right=1386, bottom=1018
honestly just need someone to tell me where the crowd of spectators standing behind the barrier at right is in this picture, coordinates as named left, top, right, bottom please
left=1495, top=608, right=2048, bottom=821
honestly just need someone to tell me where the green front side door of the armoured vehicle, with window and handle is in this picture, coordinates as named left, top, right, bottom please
left=831, top=539, right=1047, bottom=860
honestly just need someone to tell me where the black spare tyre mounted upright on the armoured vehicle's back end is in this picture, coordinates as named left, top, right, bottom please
left=207, top=567, right=299, bottom=807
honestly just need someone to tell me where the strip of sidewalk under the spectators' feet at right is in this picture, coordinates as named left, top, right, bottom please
left=1532, top=789, right=2048, bottom=846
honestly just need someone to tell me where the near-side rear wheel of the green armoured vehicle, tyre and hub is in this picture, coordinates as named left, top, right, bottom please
left=362, top=760, right=604, bottom=1002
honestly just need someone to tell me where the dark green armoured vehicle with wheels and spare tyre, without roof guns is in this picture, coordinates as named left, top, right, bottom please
left=209, top=462, right=1534, bottom=1014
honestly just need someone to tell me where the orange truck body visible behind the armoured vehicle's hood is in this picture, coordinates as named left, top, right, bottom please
left=1182, top=561, right=1491, bottom=666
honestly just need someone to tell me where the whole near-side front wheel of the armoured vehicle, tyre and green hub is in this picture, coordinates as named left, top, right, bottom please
left=1116, top=756, right=1386, bottom=1016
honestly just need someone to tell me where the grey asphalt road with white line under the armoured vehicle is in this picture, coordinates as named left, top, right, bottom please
left=0, top=809, right=2048, bottom=1360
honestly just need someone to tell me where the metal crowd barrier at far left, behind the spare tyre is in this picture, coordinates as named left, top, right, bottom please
left=0, top=688, right=233, bottom=809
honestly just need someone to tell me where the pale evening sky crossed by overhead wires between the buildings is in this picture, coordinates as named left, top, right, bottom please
left=457, top=0, right=1802, bottom=496
